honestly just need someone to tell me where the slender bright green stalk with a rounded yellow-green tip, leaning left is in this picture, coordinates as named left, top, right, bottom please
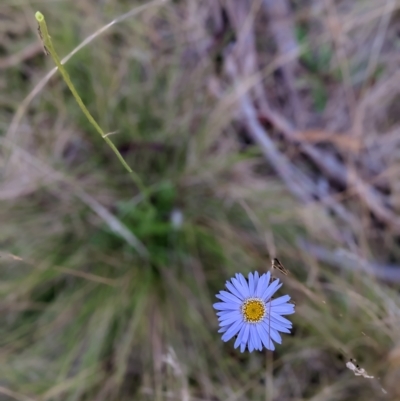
left=35, top=11, right=145, bottom=192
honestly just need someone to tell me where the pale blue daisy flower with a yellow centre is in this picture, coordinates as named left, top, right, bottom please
left=213, top=272, right=295, bottom=352
